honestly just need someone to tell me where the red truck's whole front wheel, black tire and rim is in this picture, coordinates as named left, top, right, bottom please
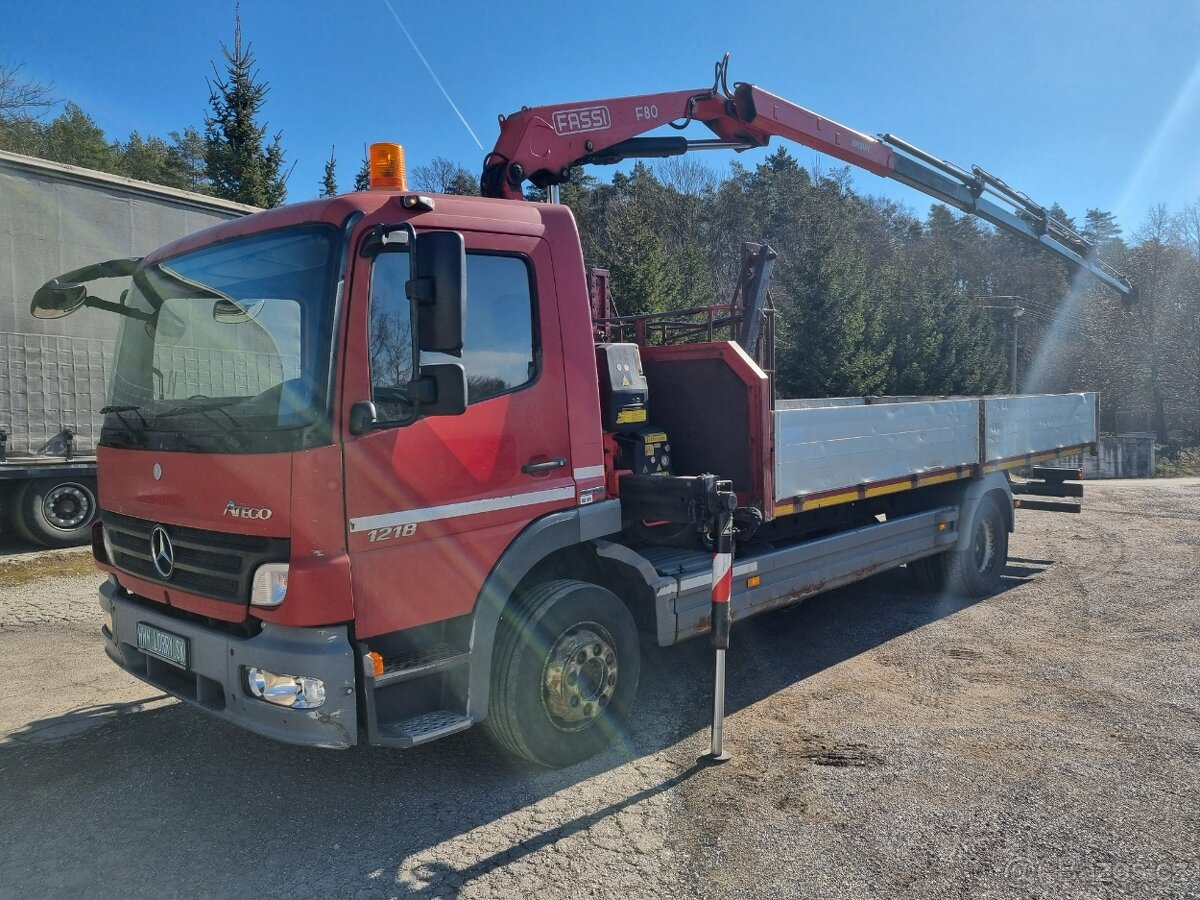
left=484, top=580, right=641, bottom=768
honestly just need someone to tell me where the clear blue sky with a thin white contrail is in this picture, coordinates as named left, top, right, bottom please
left=0, top=0, right=1200, bottom=232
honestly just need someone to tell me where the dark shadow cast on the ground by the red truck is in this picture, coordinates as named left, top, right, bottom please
left=0, top=571, right=1020, bottom=896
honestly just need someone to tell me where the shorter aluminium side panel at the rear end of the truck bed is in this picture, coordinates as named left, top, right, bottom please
left=984, top=394, right=1097, bottom=462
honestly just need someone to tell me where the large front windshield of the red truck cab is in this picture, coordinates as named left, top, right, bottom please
left=101, top=226, right=337, bottom=452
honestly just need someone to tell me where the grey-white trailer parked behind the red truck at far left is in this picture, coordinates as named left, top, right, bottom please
left=0, top=151, right=254, bottom=546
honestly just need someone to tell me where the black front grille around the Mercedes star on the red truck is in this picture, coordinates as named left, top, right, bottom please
left=100, top=510, right=290, bottom=604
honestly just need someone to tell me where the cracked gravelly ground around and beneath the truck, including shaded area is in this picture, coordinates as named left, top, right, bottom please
left=0, top=479, right=1200, bottom=898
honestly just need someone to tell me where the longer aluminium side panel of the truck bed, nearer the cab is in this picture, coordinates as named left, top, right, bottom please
left=775, top=400, right=979, bottom=500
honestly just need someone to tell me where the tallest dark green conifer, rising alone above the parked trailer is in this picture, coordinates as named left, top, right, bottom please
left=204, top=11, right=287, bottom=206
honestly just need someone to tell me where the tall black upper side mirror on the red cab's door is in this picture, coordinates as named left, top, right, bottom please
left=406, top=232, right=467, bottom=356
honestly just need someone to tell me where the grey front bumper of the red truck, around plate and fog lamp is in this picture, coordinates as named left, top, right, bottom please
left=100, top=580, right=358, bottom=749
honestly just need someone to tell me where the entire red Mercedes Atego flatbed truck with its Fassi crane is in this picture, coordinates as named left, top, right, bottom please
left=32, top=66, right=1129, bottom=766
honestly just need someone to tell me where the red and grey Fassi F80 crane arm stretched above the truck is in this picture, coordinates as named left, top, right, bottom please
left=480, top=54, right=1133, bottom=296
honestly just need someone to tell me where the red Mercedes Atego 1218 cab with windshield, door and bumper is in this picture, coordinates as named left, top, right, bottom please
left=85, top=192, right=620, bottom=763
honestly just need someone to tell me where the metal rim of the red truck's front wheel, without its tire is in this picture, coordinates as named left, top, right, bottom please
left=541, top=622, right=618, bottom=732
